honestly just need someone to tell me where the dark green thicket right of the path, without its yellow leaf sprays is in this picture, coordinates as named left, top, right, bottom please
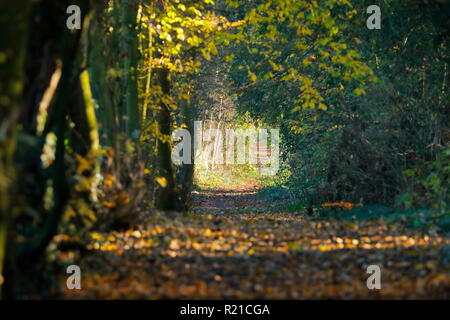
left=227, top=1, right=450, bottom=210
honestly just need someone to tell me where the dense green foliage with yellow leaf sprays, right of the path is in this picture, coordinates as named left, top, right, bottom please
left=227, top=1, right=449, bottom=207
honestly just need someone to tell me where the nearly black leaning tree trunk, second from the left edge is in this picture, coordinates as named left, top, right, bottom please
left=2, top=0, right=89, bottom=298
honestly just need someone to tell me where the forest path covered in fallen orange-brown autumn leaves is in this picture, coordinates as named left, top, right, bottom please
left=60, top=169, right=450, bottom=299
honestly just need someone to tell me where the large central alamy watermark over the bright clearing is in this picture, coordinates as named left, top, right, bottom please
left=172, top=121, right=280, bottom=175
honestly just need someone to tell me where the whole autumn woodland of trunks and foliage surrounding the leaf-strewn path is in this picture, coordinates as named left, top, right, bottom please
left=0, top=0, right=450, bottom=298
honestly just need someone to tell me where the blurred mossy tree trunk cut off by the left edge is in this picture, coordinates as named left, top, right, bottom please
left=0, top=0, right=31, bottom=296
